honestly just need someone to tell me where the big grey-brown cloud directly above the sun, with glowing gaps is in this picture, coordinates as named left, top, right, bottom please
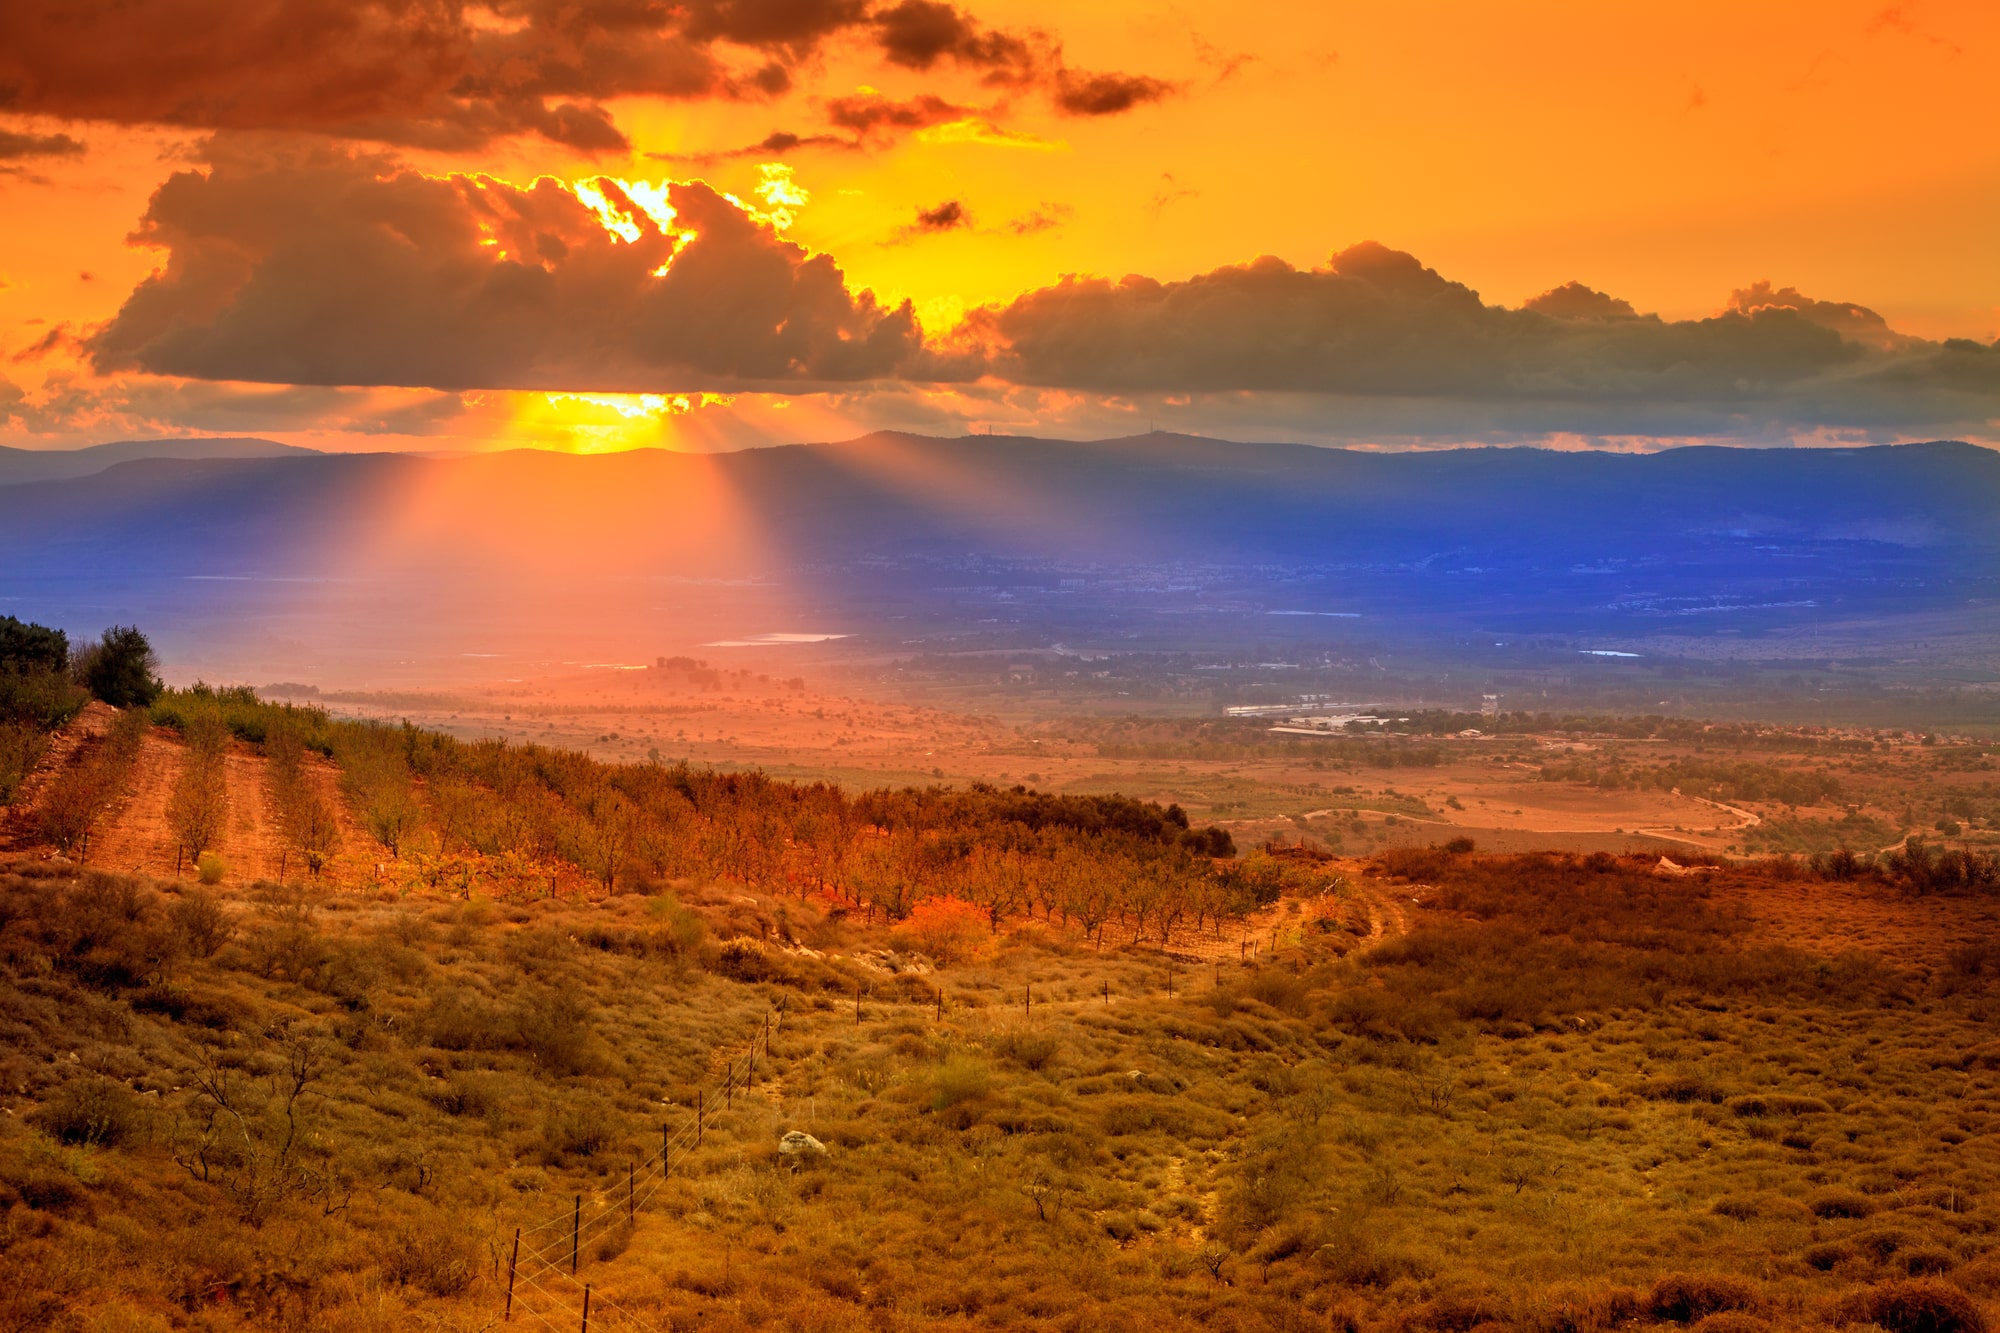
left=90, top=150, right=920, bottom=392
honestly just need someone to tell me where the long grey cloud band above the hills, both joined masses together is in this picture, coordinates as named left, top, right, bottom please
left=88, top=146, right=2000, bottom=440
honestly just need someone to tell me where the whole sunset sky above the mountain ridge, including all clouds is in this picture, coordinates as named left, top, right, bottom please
left=0, top=0, right=2000, bottom=450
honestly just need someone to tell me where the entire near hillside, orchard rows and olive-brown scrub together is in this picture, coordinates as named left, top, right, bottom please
left=0, top=693, right=2000, bottom=1333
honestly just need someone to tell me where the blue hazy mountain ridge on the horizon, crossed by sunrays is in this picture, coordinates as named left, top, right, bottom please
left=0, top=434, right=2000, bottom=679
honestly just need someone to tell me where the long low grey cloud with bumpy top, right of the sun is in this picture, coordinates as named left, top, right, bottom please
left=948, top=244, right=2000, bottom=432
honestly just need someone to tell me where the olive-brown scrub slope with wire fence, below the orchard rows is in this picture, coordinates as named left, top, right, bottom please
left=0, top=832, right=2000, bottom=1333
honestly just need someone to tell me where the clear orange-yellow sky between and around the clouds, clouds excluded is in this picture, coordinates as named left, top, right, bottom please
left=0, top=0, right=2000, bottom=448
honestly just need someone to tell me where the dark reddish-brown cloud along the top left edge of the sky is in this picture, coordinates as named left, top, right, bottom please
left=0, top=0, right=1096, bottom=150
